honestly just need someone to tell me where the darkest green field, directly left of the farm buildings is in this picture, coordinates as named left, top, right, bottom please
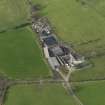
left=0, top=27, right=49, bottom=78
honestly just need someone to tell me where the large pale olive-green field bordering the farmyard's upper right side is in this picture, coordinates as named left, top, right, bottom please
left=33, top=0, right=105, bottom=46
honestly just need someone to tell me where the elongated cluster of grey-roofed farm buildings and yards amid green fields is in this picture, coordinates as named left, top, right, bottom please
left=32, top=17, right=84, bottom=70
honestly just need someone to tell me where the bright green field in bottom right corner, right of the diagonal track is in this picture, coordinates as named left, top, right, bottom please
left=73, top=81, right=105, bottom=105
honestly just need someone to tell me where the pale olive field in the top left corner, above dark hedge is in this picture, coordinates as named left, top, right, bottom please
left=0, top=0, right=29, bottom=31
